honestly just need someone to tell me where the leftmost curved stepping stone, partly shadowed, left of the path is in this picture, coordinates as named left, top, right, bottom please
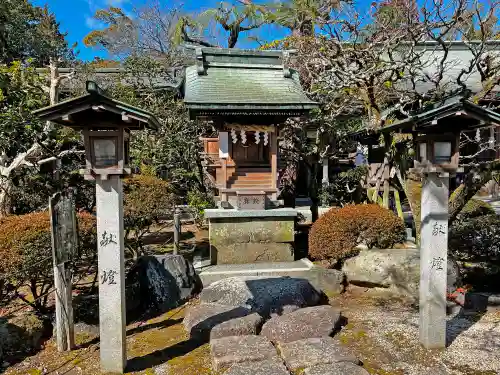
left=183, top=303, right=250, bottom=340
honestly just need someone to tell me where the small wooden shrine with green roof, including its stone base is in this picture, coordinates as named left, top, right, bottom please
left=184, top=48, right=318, bottom=264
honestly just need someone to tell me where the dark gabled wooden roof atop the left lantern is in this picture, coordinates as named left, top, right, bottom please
left=33, top=81, right=160, bottom=130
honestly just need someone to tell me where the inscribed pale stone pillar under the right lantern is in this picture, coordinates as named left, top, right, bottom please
left=420, top=173, right=449, bottom=349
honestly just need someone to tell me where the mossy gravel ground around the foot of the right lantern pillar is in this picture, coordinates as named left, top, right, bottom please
left=335, top=295, right=500, bottom=375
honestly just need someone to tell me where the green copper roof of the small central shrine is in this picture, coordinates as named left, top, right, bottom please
left=184, top=48, right=318, bottom=115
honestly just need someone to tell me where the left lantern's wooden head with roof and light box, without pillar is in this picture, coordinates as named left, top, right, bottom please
left=34, top=81, right=159, bottom=180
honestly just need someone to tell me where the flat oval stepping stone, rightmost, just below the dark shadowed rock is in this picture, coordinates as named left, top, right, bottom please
left=261, top=305, right=341, bottom=342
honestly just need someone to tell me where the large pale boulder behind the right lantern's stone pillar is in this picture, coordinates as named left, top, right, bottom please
left=342, top=249, right=460, bottom=296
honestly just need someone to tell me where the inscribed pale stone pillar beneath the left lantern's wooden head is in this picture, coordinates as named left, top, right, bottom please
left=96, top=176, right=127, bottom=374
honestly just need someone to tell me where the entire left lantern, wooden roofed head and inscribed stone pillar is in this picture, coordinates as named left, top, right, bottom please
left=34, top=82, right=159, bottom=374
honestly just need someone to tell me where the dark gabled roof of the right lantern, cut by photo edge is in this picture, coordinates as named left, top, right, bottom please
left=349, top=95, right=500, bottom=144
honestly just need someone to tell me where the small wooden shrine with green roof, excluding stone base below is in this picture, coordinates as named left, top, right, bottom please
left=184, top=48, right=317, bottom=209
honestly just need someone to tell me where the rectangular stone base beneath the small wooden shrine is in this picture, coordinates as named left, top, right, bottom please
left=205, top=208, right=297, bottom=264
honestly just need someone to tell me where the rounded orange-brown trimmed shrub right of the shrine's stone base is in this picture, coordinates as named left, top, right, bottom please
left=309, top=204, right=405, bottom=260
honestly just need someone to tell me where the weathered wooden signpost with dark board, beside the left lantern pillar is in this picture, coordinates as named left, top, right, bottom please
left=49, top=193, right=78, bottom=352
